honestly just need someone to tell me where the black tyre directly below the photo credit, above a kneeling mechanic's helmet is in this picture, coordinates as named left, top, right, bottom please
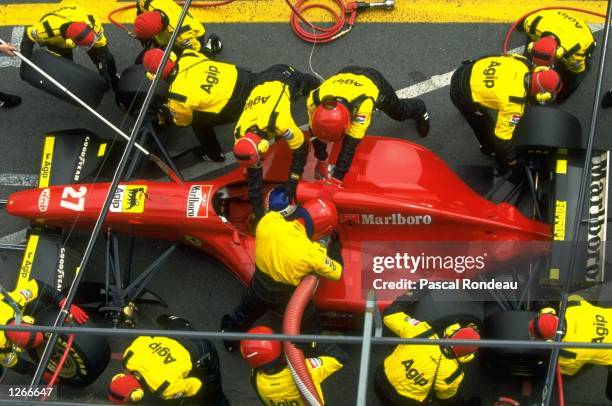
left=408, top=290, right=484, bottom=333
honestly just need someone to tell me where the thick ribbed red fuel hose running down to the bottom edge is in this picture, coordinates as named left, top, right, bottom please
left=283, top=275, right=323, bottom=406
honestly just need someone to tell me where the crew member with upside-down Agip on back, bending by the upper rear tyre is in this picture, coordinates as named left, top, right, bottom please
left=450, top=54, right=562, bottom=174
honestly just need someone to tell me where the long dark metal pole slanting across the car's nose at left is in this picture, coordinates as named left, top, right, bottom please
left=30, top=0, right=192, bottom=387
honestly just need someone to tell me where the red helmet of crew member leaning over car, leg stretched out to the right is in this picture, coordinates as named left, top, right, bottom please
left=311, top=100, right=351, bottom=142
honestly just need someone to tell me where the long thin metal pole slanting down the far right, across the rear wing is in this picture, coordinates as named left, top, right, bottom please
left=542, top=0, right=612, bottom=406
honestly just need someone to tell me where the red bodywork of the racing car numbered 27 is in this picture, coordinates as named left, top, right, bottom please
left=7, top=136, right=552, bottom=313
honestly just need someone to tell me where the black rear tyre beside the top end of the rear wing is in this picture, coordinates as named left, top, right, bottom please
left=512, top=106, right=584, bottom=155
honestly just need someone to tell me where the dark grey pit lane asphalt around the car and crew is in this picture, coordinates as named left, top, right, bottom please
left=0, top=20, right=612, bottom=405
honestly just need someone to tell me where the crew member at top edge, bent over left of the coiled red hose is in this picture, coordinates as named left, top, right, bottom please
left=134, top=0, right=223, bottom=56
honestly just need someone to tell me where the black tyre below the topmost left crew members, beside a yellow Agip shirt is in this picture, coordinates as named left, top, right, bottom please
left=115, top=65, right=169, bottom=116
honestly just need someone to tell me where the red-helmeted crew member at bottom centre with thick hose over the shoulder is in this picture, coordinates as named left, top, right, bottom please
left=240, top=326, right=348, bottom=406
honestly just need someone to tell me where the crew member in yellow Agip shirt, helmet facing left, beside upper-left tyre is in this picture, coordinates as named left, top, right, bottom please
left=143, top=48, right=255, bottom=162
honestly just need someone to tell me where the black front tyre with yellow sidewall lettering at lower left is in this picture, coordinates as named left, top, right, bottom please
left=30, top=306, right=110, bottom=387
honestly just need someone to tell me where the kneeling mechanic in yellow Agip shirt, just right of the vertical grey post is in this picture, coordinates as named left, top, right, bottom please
left=374, top=296, right=480, bottom=405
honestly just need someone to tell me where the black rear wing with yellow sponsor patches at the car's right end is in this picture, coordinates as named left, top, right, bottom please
left=548, top=150, right=610, bottom=289
